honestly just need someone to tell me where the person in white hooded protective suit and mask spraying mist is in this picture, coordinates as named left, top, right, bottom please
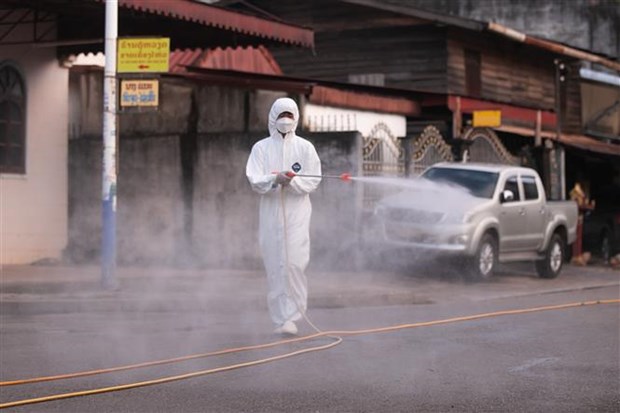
left=246, top=98, right=321, bottom=334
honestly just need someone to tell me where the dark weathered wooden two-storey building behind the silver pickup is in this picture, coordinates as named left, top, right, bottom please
left=221, top=0, right=620, bottom=198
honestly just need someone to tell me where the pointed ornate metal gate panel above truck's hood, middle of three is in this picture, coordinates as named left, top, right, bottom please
left=409, top=125, right=454, bottom=176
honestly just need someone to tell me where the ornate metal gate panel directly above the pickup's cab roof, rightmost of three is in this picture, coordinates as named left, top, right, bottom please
left=462, top=128, right=520, bottom=165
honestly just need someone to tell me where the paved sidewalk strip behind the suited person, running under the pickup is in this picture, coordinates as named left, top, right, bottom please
left=0, top=265, right=620, bottom=315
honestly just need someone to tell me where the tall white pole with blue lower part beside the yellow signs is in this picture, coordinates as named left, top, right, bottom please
left=101, top=0, right=118, bottom=289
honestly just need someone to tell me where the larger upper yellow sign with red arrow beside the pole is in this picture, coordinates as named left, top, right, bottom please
left=116, top=37, right=170, bottom=73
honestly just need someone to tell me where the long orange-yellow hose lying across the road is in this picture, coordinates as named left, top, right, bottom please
left=0, top=299, right=620, bottom=409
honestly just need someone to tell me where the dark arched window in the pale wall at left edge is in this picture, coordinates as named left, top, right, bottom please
left=0, top=63, right=26, bottom=174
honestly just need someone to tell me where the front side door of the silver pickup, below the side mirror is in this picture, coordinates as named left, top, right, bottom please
left=499, top=174, right=526, bottom=252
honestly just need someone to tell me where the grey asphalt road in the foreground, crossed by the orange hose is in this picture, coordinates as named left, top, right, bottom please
left=0, top=287, right=620, bottom=412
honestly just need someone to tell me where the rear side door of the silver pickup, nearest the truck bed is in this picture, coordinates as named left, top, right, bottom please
left=521, top=175, right=546, bottom=250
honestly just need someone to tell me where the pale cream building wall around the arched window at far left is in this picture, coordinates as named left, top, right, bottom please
left=0, top=19, right=69, bottom=264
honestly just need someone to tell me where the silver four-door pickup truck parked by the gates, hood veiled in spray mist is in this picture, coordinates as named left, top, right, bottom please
left=375, top=163, right=577, bottom=280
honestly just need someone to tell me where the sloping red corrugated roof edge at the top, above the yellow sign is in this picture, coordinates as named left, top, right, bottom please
left=115, top=0, right=314, bottom=47
